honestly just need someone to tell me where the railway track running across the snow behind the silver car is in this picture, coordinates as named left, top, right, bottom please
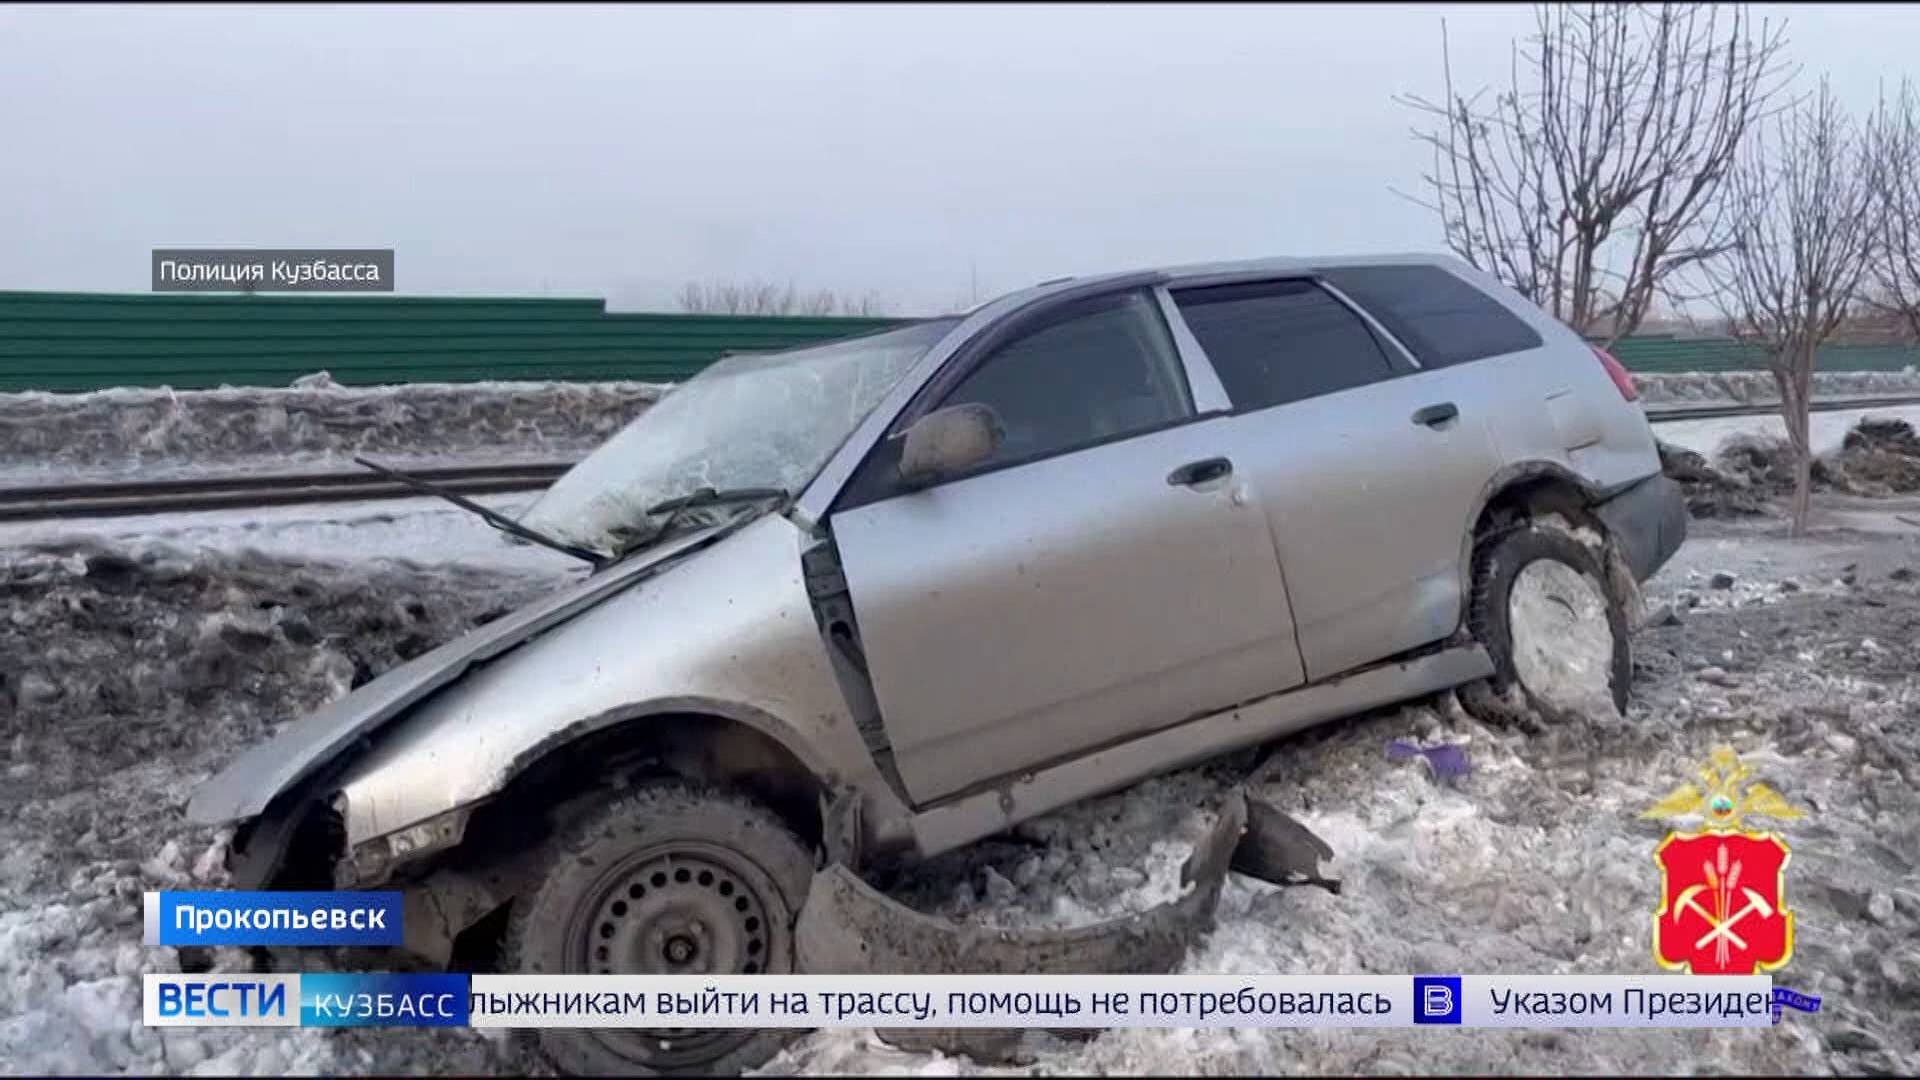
left=0, top=396, right=1920, bottom=521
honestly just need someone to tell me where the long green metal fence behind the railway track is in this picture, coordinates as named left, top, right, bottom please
left=0, top=292, right=1920, bottom=390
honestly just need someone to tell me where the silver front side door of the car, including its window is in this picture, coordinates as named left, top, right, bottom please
left=829, top=290, right=1302, bottom=803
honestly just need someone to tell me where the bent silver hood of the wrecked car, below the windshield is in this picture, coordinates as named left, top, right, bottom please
left=186, top=513, right=741, bottom=824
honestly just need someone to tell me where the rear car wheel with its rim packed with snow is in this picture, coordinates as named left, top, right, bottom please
left=1459, top=523, right=1634, bottom=730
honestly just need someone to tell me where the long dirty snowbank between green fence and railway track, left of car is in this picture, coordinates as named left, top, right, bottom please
left=0, top=375, right=664, bottom=482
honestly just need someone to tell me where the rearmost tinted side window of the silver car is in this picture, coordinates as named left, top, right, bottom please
left=1321, top=267, right=1540, bottom=367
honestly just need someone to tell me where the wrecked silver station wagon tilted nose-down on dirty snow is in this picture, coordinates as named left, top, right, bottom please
left=190, top=256, right=1686, bottom=1072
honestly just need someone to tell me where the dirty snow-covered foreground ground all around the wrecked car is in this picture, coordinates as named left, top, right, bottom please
left=0, top=519, right=1920, bottom=1074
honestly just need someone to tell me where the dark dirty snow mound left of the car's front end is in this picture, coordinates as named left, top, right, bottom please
left=0, top=548, right=560, bottom=1074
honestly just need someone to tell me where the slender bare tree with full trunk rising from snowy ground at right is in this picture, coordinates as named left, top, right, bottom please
left=1703, top=79, right=1885, bottom=536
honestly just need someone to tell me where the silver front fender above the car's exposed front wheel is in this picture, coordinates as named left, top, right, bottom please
left=330, top=515, right=885, bottom=859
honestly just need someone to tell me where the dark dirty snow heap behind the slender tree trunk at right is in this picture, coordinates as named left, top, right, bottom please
left=1661, top=417, right=1920, bottom=517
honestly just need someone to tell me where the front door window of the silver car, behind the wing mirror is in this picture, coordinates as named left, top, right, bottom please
left=941, top=292, right=1192, bottom=463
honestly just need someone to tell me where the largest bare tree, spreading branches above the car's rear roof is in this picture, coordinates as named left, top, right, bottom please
left=1398, top=4, right=1791, bottom=344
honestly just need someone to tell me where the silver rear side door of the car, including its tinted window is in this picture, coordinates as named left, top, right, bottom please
left=1173, top=279, right=1498, bottom=680
